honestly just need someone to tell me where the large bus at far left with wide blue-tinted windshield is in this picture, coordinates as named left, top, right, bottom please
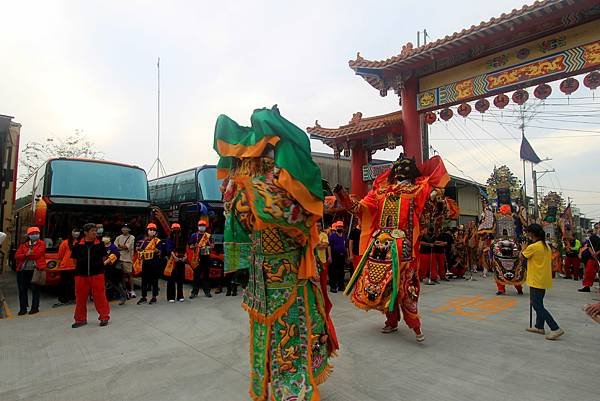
left=12, top=158, right=150, bottom=285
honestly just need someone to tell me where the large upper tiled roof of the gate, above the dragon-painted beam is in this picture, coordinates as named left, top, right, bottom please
left=349, top=0, right=600, bottom=95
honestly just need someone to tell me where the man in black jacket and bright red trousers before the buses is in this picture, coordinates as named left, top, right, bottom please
left=71, top=223, right=110, bottom=329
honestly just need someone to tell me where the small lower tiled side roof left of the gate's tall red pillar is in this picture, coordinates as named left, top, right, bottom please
left=306, top=111, right=402, bottom=141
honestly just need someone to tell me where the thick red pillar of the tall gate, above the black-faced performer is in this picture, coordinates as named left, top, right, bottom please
left=400, top=78, right=423, bottom=165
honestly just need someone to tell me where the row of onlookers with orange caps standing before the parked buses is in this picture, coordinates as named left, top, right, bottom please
left=15, top=219, right=238, bottom=328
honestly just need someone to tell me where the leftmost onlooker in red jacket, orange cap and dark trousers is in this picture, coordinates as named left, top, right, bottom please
left=15, top=227, right=46, bottom=316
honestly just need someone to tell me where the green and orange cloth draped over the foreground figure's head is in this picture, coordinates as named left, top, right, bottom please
left=214, top=106, right=323, bottom=278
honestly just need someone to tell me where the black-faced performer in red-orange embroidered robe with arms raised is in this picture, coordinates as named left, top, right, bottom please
left=335, top=154, right=450, bottom=342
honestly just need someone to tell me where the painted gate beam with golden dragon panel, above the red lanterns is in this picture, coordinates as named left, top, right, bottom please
left=417, top=21, right=600, bottom=111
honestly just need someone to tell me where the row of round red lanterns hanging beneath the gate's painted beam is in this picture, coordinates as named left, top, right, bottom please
left=423, top=71, right=600, bottom=125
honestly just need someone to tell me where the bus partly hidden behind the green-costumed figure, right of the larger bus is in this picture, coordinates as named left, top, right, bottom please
left=148, top=165, right=225, bottom=280
